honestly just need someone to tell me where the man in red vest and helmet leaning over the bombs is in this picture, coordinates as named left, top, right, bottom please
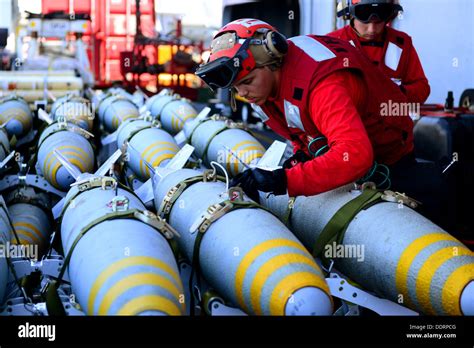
left=196, top=19, right=452, bottom=230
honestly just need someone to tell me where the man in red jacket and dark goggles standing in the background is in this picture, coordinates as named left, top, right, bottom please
left=328, top=0, right=430, bottom=104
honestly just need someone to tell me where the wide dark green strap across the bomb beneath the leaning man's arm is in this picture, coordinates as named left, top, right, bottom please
left=313, top=189, right=382, bottom=264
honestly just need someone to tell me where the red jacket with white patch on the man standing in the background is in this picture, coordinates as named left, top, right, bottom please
left=328, top=25, right=430, bottom=103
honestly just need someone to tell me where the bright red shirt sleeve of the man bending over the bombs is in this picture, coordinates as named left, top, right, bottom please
left=286, top=70, right=374, bottom=196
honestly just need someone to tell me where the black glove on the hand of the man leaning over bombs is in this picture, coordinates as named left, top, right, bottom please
left=229, top=168, right=287, bottom=203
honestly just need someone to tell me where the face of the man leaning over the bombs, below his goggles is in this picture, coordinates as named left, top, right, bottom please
left=233, top=66, right=277, bottom=105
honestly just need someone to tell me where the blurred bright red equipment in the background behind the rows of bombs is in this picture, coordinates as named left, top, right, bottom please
left=42, top=0, right=203, bottom=99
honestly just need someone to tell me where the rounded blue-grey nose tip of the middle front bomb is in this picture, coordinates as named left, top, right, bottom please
left=285, top=287, right=332, bottom=315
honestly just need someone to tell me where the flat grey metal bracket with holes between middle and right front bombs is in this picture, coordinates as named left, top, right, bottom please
left=326, top=273, right=419, bottom=316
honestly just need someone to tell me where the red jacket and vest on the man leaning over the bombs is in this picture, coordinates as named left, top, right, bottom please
left=253, top=35, right=413, bottom=196
